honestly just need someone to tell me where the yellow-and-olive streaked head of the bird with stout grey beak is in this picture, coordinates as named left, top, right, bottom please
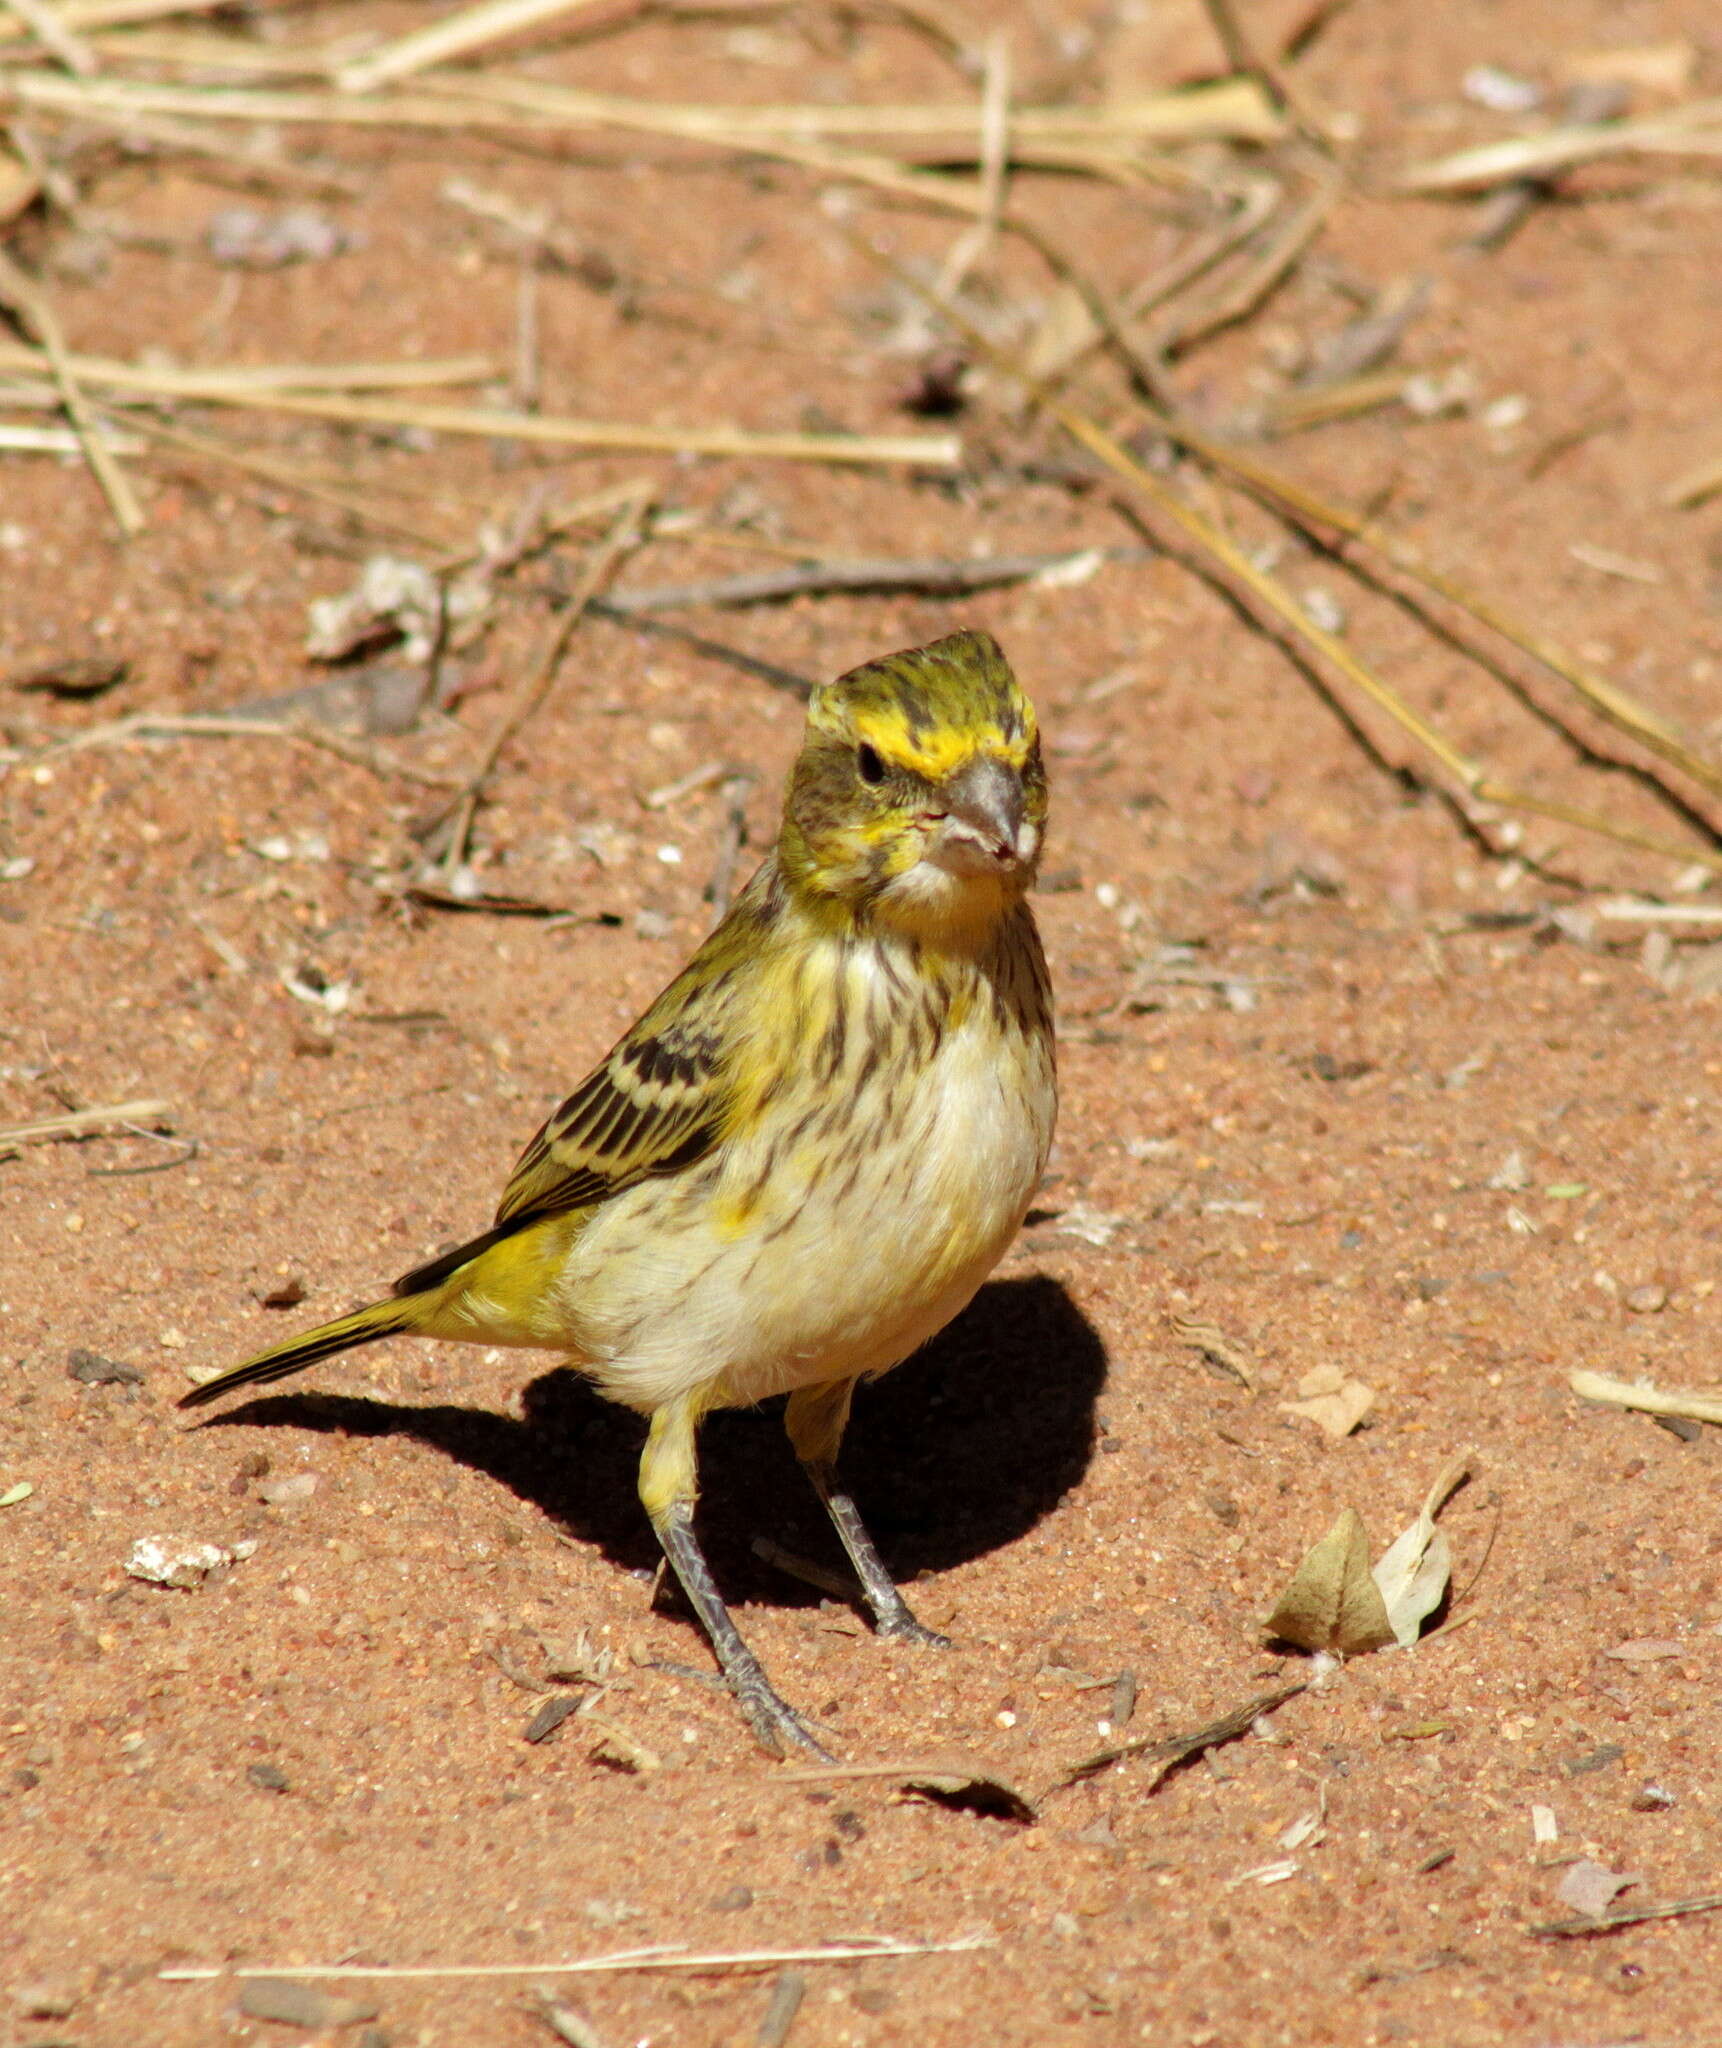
left=780, top=633, right=1046, bottom=932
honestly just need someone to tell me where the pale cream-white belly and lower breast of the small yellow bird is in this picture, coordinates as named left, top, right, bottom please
left=563, top=974, right=1054, bottom=1409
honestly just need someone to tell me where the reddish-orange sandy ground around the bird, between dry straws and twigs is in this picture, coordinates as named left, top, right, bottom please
left=0, top=0, right=1722, bottom=2048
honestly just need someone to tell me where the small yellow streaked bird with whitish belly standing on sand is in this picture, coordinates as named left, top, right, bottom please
left=180, top=631, right=1057, bottom=1757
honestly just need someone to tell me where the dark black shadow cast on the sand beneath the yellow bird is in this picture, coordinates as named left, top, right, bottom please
left=188, top=1276, right=1106, bottom=1606
